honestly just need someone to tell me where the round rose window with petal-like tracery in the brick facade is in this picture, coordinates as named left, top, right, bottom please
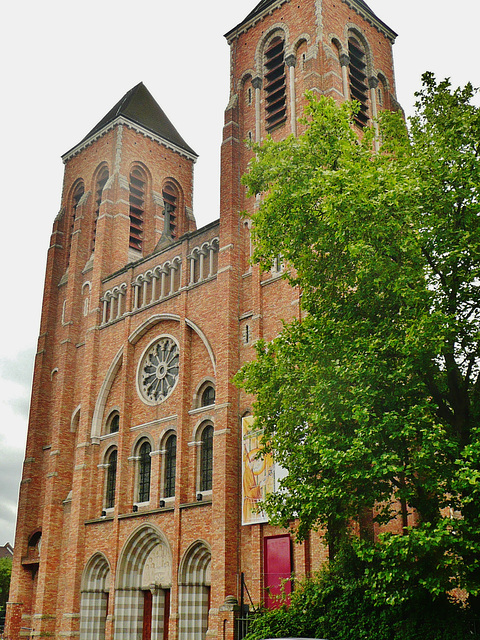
left=138, top=336, right=180, bottom=404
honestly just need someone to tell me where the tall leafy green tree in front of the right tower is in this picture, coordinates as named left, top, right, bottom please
left=237, top=73, right=480, bottom=606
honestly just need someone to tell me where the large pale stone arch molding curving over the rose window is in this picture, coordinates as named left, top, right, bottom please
left=90, top=313, right=216, bottom=443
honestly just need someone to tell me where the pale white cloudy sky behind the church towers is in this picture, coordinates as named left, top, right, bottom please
left=0, top=0, right=480, bottom=545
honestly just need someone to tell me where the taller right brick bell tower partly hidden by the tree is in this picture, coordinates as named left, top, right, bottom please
left=219, top=0, right=399, bottom=620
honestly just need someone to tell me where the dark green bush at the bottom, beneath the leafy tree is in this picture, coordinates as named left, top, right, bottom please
left=246, top=550, right=480, bottom=640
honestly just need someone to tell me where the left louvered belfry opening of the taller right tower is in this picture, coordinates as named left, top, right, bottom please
left=265, top=37, right=287, bottom=131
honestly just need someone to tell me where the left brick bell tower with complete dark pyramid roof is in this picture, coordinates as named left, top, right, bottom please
left=9, top=83, right=197, bottom=634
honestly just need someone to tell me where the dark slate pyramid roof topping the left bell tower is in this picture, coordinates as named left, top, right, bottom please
left=65, top=82, right=197, bottom=156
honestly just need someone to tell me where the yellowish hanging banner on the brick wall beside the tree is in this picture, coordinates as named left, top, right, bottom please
left=242, top=416, right=275, bottom=524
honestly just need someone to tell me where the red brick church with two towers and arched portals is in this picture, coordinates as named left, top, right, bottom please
left=6, top=0, right=397, bottom=640
